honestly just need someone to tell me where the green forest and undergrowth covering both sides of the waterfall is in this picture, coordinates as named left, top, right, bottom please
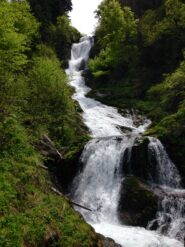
left=0, top=0, right=185, bottom=247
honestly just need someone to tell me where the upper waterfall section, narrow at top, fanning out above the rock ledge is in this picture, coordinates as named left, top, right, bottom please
left=66, top=37, right=151, bottom=137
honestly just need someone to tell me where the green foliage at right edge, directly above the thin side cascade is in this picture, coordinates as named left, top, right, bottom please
left=145, top=58, right=185, bottom=178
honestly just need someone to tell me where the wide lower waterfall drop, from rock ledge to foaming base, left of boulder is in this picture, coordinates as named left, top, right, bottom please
left=73, top=136, right=134, bottom=223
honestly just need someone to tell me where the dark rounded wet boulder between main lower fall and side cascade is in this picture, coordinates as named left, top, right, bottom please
left=118, top=176, right=158, bottom=227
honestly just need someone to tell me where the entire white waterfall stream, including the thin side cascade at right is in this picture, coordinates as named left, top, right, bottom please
left=66, top=37, right=185, bottom=247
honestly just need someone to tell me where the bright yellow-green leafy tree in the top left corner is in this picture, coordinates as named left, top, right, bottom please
left=0, top=1, right=38, bottom=74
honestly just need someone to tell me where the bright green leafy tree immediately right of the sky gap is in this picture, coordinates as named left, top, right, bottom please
left=89, top=0, right=137, bottom=77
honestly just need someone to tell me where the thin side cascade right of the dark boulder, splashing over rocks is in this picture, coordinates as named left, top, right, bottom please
left=148, top=137, right=185, bottom=242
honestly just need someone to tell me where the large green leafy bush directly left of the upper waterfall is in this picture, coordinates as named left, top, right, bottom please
left=23, top=45, right=86, bottom=147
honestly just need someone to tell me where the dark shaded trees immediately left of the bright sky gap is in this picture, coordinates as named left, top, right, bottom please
left=28, top=0, right=80, bottom=63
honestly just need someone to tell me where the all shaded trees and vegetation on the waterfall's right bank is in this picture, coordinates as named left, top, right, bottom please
left=87, top=0, right=185, bottom=181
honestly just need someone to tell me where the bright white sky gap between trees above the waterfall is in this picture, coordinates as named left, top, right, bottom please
left=70, top=0, right=102, bottom=35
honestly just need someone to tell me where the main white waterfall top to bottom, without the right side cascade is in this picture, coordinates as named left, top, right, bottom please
left=66, top=37, right=183, bottom=247
